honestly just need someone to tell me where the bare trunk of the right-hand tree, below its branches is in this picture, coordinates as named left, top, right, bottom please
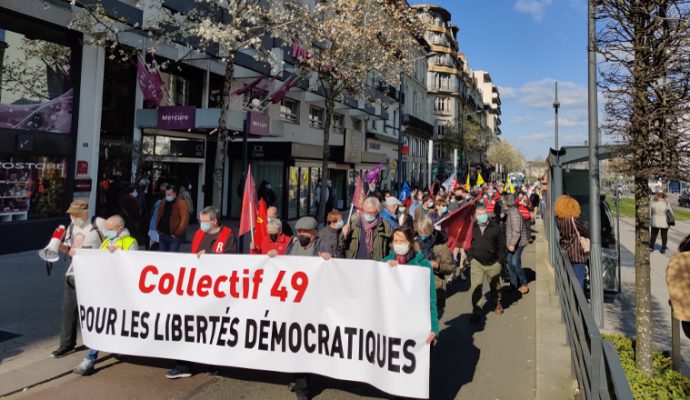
left=635, top=176, right=652, bottom=376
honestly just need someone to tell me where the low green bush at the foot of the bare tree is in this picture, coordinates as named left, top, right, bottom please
left=601, top=334, right=690, bottom=400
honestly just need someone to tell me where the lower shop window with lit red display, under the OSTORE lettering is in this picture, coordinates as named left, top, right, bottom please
left=0, top=156, right=67, bottom=222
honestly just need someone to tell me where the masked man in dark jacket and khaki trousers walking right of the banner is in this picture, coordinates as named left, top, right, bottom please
left=467, top=204, right=506, bottom=323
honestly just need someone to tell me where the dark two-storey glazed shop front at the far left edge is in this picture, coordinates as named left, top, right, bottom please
left=0, top=11, right=81, bottom=254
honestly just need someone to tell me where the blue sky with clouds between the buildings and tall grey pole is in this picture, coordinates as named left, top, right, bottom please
left=410, top=0, right=601, bottom=160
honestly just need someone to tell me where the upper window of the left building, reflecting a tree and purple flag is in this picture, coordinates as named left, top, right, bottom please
left=0, top=27, right=74, bottom=134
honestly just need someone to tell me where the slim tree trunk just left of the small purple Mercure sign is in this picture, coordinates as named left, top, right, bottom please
left=211, top=54, right=235, bottom=214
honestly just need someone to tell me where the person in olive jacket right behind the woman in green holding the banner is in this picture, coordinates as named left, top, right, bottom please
left=416, top=217, right=453, bottom=315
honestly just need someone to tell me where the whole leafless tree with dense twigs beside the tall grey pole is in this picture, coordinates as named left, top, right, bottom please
left=597, top=0, right=690, bottom=375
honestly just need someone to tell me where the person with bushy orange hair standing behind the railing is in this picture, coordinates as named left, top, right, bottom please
left=554, top=194, right=589, bottom=289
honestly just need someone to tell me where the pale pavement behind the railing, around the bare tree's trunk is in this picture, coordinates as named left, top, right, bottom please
left=604, top=214, right=690, bottom=375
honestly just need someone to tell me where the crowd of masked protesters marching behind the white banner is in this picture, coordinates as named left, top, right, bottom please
left=51, top=174, right=544, bottom=399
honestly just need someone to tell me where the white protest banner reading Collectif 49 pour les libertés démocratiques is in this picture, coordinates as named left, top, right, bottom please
left=74, top=250, right=431, bottom=398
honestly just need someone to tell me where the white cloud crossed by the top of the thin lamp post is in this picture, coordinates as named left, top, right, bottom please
left=518, top=78, right=587, bottom=108
